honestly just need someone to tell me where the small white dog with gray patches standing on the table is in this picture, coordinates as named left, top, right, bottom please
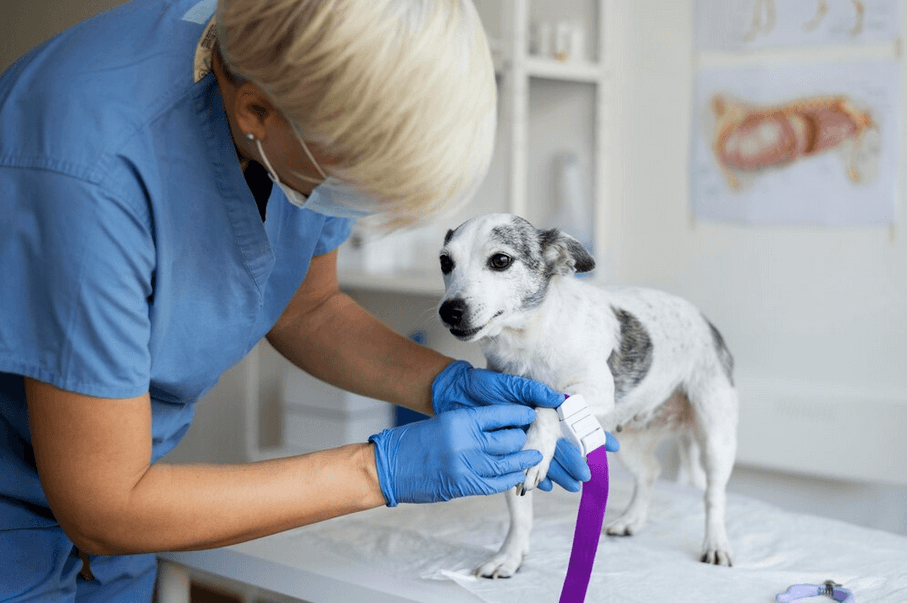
left=439, top=214, right=737, bottom=578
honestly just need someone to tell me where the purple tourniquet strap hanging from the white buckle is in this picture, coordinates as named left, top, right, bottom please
left=560, top=446, right=608, bottom=603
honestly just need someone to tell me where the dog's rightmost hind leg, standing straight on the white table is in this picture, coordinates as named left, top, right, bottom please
left=691, top=376, right=738, bottom=566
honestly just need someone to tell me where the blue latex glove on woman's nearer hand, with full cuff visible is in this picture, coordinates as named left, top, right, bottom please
left=369, top=405, right=542, bottom=507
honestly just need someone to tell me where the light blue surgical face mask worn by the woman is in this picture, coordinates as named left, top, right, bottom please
left=247, top=134, right=378, bottom=218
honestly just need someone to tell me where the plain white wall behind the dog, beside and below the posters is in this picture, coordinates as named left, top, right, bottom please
left=608, top=0, right=907, bottom=420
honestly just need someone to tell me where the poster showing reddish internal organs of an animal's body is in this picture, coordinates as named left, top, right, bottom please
left=691, top=60, right=901, bottom=225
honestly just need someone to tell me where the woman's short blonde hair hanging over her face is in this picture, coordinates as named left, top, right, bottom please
left=217, top=0, right=497, bottom=225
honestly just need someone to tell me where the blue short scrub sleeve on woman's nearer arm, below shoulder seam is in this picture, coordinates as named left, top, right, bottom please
left=0, top=169, right=155, bottom=398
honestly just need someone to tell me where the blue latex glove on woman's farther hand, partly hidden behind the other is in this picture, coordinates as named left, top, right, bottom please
left=431, top=360, right=620, bottom=492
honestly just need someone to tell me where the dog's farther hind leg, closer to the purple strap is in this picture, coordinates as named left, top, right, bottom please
left=605, top=429, right=662, bottom=536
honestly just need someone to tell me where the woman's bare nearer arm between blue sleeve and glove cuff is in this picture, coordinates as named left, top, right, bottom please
left=25, top=379, right=385, bottom=555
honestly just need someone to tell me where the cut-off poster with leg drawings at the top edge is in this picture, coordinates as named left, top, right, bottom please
left=696, top=0, right=901, bottom=51
